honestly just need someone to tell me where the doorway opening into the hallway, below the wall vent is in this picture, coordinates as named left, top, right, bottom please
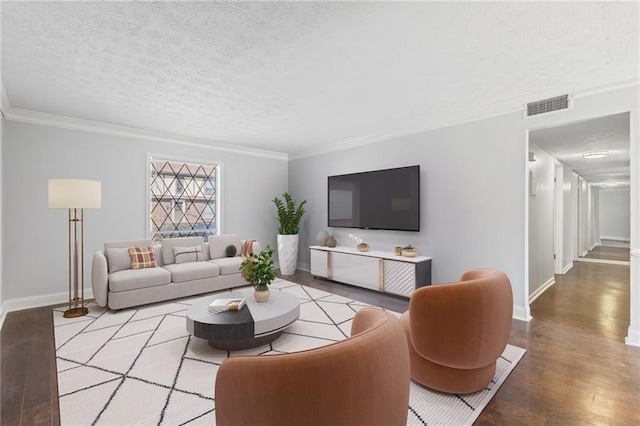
left=529, top=113, right=631, bottom=342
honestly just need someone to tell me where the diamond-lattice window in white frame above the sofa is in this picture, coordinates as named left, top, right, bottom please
left=149, top=157, right=219, bottom=241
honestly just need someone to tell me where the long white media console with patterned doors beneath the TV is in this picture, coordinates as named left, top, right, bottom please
left=309, top=246, right=431, bottom=297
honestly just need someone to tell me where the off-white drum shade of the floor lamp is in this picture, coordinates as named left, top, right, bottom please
left=49, top=179, right=102, bottom=209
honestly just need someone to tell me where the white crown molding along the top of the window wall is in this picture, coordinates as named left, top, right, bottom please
left=3, top=106, right=288, bottom=161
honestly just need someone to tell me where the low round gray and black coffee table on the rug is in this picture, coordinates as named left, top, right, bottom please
left=187, top=289, right=300, bottom=350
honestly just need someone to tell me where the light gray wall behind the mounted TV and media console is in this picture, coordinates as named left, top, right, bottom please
left=289, top=113, right=528, bottom=314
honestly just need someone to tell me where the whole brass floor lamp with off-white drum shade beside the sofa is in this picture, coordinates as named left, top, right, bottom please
left=49, top=179, right=101, bottom=318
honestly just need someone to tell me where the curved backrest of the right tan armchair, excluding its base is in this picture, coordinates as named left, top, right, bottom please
left=409, top=269, right=513, bottom=369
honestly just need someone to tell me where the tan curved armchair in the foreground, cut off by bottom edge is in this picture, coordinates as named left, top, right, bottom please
left=215, top=308, right=410, bottom=426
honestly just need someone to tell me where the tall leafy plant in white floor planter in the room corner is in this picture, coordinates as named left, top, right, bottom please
left=273, top=192, right=307, bottom=275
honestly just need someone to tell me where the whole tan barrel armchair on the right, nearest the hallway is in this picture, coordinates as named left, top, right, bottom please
left=400, top=269, right=513, bottom=394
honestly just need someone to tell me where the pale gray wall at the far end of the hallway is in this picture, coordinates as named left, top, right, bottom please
left=599, top=188, right=631, bottom=241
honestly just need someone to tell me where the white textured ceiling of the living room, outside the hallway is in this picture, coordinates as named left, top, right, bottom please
left=1, top=1, right=639, bottom=157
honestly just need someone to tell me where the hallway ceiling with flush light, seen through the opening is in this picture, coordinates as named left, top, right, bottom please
left=529, top=113, right=630, bottom=186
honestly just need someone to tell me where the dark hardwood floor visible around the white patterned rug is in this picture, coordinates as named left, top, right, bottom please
left=0, top=262, right=640, bottom=425
